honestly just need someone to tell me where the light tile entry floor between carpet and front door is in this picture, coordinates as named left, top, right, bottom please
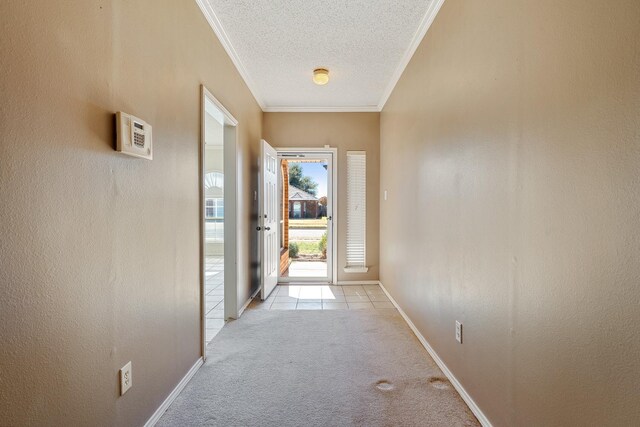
left=249, top=285, right=395, bottom=310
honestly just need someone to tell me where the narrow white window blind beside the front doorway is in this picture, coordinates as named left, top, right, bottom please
left=345, top=151, right=368, bottom=272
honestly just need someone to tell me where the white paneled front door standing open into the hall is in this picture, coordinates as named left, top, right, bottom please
left=258, top=139, right=280, bottom=300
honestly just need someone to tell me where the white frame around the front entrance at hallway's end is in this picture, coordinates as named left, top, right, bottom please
left=274, top=145, right=338, bottom=285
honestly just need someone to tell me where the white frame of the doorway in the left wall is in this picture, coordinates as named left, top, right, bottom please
left=198, top=84, right=238, bottom=360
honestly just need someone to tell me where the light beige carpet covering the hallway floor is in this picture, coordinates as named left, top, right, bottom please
left=157, top=310, right=479, bottom=426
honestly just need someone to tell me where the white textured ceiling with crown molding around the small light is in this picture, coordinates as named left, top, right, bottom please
left=196, top=0, right=443, bottom=111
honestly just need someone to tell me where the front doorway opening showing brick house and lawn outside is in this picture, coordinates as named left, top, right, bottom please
left=278, top=149, right=335, bottom=283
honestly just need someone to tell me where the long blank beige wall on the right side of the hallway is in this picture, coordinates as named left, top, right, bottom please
left=380, top=0, right=640, bottom=426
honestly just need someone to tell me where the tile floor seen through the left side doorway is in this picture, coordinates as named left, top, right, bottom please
left=204, top=256, right=224, bottom=344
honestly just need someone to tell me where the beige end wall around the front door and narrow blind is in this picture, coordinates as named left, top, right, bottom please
left=262, top=113, right=380, bottom=281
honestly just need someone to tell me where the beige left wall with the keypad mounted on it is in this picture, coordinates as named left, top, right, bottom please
left=0, top=0, right=262, bottom=426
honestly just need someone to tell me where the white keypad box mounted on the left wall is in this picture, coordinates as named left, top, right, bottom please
left=116, top=111, right=153, bottom=160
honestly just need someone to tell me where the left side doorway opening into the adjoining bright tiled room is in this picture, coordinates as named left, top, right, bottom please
left=200, top=86, right=237, bottom=356
